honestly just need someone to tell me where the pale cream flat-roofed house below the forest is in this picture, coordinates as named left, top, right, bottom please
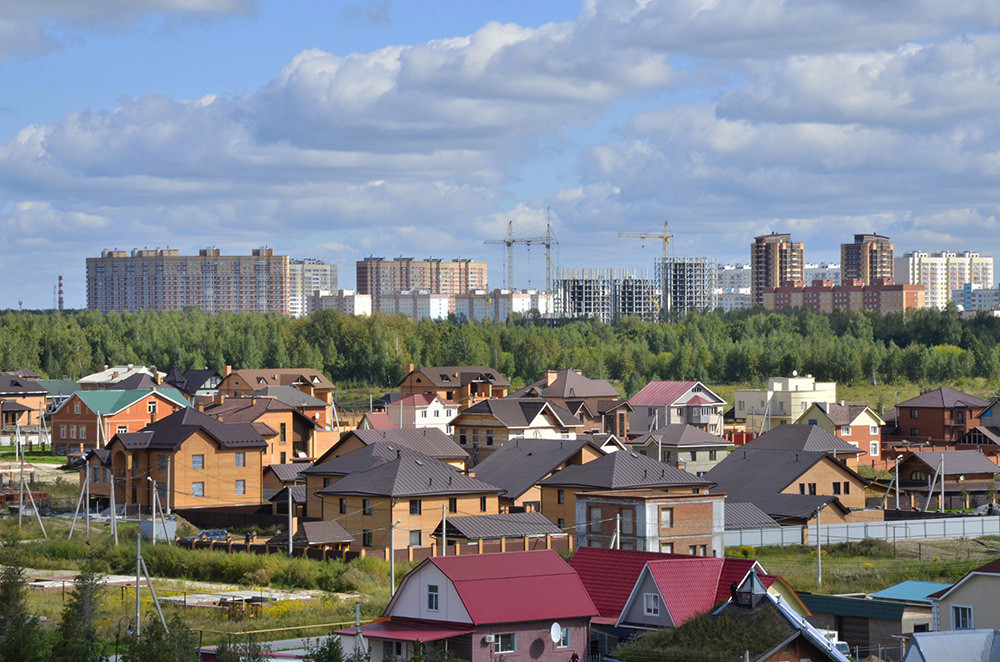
left=733, top=374, right=837, bottom=432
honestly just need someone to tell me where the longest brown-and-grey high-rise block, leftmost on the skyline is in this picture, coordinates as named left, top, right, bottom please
left=87, top=248, right=288, bottom=314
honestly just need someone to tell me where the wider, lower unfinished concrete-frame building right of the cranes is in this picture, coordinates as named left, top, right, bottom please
left=555, top=269, right=663, bottom=323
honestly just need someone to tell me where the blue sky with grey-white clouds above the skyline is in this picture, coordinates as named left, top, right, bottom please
left=0, top=0, right=1000, bottom=309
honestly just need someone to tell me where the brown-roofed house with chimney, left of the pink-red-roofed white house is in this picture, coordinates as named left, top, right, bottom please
left=510, top=368, right=632, bottom=439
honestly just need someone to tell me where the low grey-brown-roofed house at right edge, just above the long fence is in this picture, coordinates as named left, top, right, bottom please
left=899, top=450, right=1000, bottom=509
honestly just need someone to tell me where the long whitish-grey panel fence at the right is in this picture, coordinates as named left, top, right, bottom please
left=724, top=516, right=1000, bottom=547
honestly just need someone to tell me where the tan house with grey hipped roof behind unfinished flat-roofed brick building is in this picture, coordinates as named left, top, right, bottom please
left=538, top=451, right=712, bottom=536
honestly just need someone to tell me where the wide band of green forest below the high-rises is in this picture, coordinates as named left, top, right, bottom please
left=0, top=308, right=1000, bottom=395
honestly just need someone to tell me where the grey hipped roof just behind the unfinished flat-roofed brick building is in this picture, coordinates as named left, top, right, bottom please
left=539, top=451, right=712, bottom=490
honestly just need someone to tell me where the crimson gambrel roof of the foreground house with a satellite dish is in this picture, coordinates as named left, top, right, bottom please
left=398, top=549, right=597, bottom=625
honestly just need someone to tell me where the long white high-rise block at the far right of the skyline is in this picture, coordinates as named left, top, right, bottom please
left=894, top=251, right=993, bottom=309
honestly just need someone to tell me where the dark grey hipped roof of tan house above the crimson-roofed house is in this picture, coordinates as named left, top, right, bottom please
left=316, top=453, right=500, bottom=498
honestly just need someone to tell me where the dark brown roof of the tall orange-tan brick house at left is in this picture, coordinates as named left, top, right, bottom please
left=109, top=407, right=267, bottom=450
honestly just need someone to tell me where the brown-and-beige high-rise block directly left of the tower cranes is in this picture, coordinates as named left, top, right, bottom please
left=357, top=257, right=487, bottom=311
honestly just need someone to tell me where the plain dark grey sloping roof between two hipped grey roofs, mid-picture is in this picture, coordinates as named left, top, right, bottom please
left=475, top=438, right=589, bottom=499
